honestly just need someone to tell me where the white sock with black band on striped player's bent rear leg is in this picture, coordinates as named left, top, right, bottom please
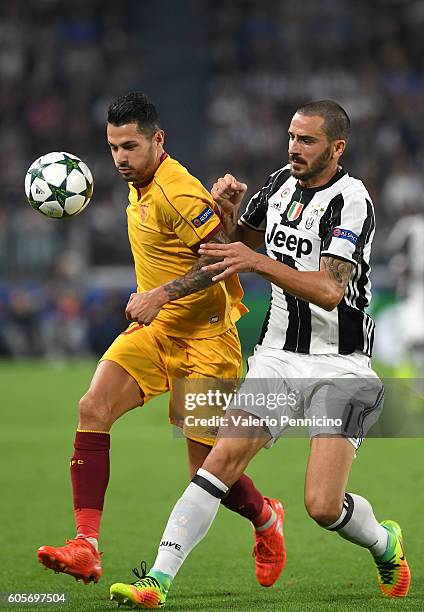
left=326, top=493, right=388, bottom=557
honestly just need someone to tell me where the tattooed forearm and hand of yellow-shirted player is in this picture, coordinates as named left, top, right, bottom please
left=125, top=230, right=230, bottom=325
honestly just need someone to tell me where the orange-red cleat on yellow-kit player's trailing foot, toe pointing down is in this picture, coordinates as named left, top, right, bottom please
left=253, top=497, right=286, bottom=587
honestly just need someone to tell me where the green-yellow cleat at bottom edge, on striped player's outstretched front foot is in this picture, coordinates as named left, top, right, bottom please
left=110, top=561, right=171, bottom=608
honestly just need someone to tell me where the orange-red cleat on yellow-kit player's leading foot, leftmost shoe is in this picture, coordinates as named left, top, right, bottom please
left=37, top=538, right=102, bottom=584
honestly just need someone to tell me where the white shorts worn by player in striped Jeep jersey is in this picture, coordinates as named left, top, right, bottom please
left=227, top=347, right=384, bottom=448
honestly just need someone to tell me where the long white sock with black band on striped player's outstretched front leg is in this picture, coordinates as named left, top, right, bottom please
left=152, top=468, right=228, bottom=578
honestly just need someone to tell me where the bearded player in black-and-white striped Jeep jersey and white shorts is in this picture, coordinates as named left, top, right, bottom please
left=111, top=100, right=410, bottom=607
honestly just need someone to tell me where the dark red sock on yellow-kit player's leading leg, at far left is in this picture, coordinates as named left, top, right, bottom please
left=71, top=431, right=110, bottom=539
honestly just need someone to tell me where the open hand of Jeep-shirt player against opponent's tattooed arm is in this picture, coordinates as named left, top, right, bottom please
left=199, top=242, right=263, bottom=281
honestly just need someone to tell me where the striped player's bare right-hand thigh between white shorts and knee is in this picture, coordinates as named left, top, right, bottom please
left=305, top=436, right=355, bottom=505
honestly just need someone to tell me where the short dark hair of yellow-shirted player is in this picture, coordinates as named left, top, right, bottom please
left=107, top=91, right=160, bottom=135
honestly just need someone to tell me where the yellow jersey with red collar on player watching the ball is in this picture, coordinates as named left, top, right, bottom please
left=127, top=155, right=247, bottom=338
